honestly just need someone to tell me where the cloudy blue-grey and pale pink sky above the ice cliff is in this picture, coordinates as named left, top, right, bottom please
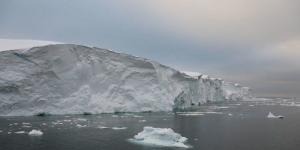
left=0, top=0, right=300, bottom=97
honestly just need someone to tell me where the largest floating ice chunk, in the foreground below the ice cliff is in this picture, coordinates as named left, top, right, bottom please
left=129, top=126, right=190, bottom=148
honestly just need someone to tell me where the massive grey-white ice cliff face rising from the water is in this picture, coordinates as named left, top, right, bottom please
left=0, top=44, right=249, bottom=116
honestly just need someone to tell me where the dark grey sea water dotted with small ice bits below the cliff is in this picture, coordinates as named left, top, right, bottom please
left=0, top=100, right=300, bottom=150
